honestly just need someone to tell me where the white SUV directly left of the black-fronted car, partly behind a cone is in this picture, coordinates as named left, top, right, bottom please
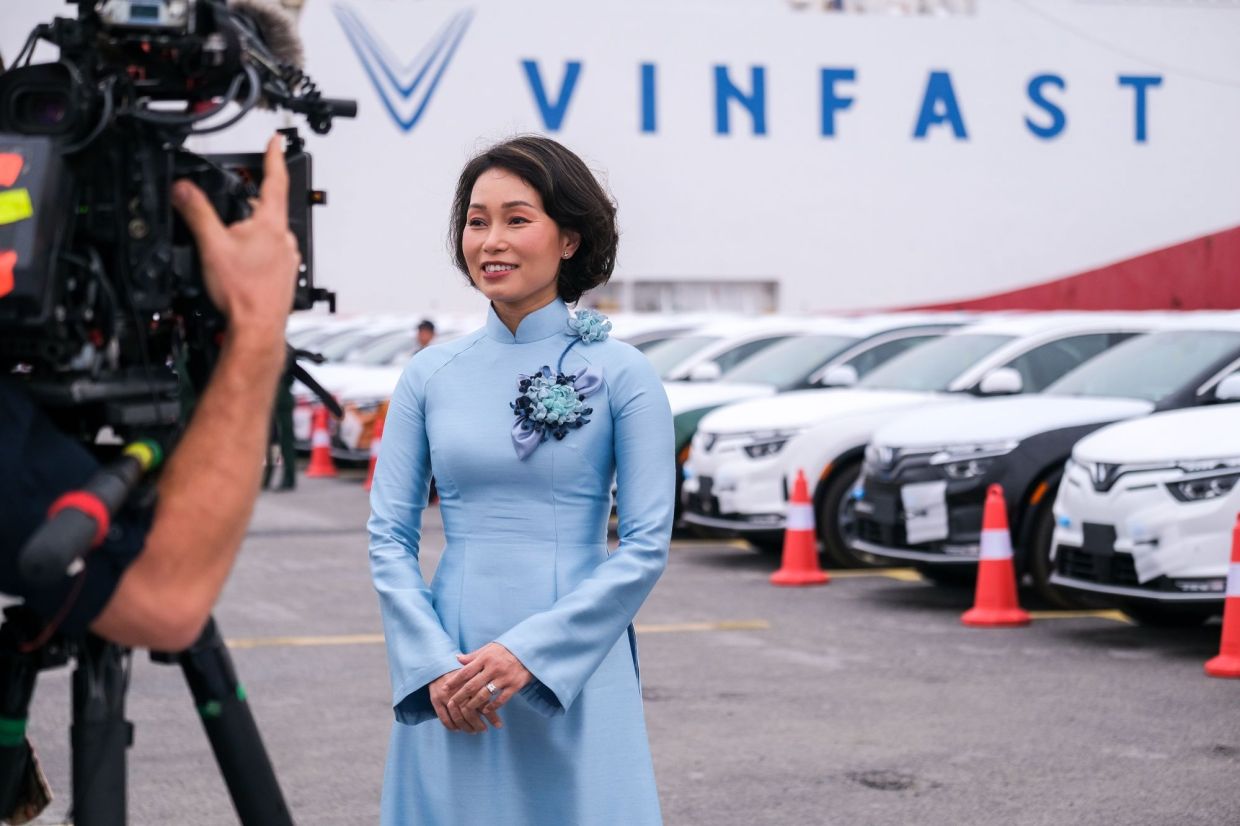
left=682, top=313, right=1156, bottom=555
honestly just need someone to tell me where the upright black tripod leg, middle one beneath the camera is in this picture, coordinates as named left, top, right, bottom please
left=69, top=635, right=134, bottom=826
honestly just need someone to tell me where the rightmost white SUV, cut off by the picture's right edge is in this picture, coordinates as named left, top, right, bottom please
left=1050, top=399, right=1240, bottom=625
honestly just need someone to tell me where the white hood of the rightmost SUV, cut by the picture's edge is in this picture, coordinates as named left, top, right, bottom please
left=1073, top=404, right=1240, bottom=465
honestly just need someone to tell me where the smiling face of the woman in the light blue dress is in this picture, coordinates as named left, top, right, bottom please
left=461, top=169, right=579, bottom=310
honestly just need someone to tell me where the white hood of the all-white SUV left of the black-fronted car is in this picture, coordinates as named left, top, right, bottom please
left=698, top=389, right=940, bottom=433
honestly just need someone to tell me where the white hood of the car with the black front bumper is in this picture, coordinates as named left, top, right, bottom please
left=874, top=396, right=1154, bottom=448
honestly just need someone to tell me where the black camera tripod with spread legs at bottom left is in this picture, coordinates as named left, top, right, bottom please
left=0, top=606, right=293, bottom=826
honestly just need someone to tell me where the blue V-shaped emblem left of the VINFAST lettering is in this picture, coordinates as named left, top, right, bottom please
left=334, top=4, right=474, bottom=131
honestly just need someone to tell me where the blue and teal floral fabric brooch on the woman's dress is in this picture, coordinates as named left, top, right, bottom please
left=508, top=310, right=611, bottom=460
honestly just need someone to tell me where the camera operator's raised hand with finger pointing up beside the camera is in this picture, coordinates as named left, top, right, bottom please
left=172, top=135, right=301, bottom=341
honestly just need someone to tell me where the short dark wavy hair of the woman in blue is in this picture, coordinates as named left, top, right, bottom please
left=449, top=135, right=620, bottom=304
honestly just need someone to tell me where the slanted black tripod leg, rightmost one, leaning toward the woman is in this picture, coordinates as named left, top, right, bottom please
left=177, top=619, right=293, bottom=826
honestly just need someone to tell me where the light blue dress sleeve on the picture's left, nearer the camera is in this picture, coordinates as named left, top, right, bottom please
left=367, top=360, right=460, bottom=724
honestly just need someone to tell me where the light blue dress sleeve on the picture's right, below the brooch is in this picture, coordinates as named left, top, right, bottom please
left=496, top=352, right=676, bottom=716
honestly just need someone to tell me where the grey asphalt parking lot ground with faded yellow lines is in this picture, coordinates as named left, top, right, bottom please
left=21, top=471, right=1240, bottom=826
